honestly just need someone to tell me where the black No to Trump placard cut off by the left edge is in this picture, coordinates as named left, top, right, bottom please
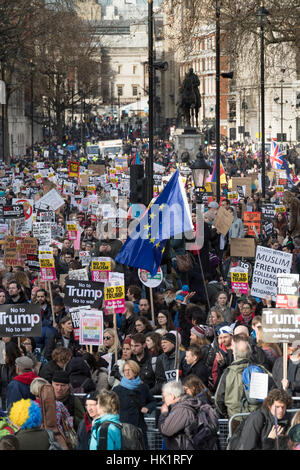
left=0, top=303, right=42, bottom=337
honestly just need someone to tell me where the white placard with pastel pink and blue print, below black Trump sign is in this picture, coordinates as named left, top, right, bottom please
left=79, top=310, right=103, bottom=346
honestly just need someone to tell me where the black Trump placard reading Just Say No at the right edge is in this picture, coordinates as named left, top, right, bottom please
left=262, top=308, right=300, bottom=343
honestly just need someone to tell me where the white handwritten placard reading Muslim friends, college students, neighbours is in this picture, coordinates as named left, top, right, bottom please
left=251, top=246, right=293, bottom=300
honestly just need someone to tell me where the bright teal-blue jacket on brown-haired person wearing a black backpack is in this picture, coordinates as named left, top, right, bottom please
left=90, top=414, right=122, bottom=450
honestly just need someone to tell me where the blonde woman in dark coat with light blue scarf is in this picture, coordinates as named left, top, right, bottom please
left=114, top=360, right=156, bottom=448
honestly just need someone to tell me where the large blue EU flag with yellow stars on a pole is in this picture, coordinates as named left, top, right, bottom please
left=115, top=170, right=193, bottom=276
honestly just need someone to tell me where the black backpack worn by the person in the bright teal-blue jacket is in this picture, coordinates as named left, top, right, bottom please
left=96, top=421, right=146, bottom=450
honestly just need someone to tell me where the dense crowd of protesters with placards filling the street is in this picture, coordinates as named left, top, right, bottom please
left=0, top=129, right=300, bottom=451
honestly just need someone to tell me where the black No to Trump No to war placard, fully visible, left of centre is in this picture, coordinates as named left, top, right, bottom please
left=64, top=279, right=104, bottom=308
